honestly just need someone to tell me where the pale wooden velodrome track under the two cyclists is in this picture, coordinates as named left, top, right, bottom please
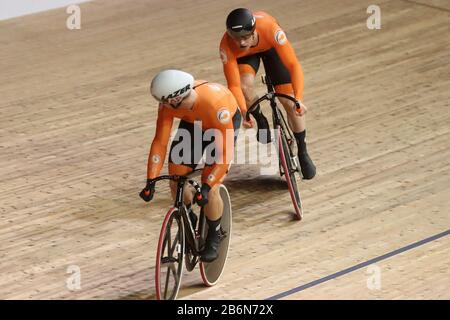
left=0, top=0, right=450, bottom=299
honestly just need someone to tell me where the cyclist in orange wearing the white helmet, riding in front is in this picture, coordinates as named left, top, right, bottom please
left=140, top=70, right=241, bottom=262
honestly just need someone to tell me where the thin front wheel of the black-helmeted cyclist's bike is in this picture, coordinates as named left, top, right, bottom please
left=277, top=125, right=303, bottom=220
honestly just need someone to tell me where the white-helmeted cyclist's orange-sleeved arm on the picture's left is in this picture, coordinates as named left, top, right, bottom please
left=147, top=107, right=173, bottom=179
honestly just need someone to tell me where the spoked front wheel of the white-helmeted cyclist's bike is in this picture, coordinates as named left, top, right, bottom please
left=155, top=208, right=185, bottom=300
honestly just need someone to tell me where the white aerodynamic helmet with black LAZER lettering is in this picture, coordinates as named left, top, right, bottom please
left=150, top=69, right=194, bottom=108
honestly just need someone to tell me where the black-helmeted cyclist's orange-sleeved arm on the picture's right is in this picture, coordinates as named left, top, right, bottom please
left=273, top=27, right=304, bottom=101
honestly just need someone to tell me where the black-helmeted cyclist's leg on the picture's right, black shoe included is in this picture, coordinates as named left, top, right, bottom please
left=263, top=49, right=316, bottom=179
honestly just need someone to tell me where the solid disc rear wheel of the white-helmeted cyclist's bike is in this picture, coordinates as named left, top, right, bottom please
left=200, top=185, right=232, bottom=287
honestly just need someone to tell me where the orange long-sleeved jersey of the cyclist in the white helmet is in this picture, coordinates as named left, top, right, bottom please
left=147, top=80, right=238, bottom=187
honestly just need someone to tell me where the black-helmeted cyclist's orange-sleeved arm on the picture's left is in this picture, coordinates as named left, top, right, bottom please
left=220, top=45, right=247, bottom=114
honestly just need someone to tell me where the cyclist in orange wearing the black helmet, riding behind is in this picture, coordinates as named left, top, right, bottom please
left=220, top=8, right=316, bottom=179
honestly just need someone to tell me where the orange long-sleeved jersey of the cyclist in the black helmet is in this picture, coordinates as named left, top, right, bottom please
left=220, top=11, right=304, bottom=113
